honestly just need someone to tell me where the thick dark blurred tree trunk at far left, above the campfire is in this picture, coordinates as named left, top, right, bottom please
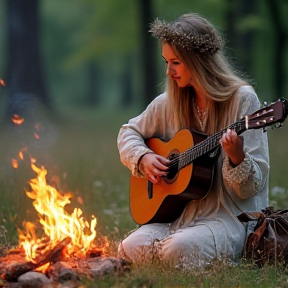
left=6, top=0, right=51, bottom=117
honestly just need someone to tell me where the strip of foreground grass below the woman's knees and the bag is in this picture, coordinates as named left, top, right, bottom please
left=80, top=261, right=287, bottom=288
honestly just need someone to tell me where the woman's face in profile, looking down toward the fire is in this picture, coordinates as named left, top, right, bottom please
left=162, top=43, right=191, bottom=88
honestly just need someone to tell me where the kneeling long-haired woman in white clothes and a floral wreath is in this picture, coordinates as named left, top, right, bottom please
left=118, top=14, right=269, bottom=268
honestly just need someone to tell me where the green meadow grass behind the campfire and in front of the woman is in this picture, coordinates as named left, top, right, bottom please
left=0, top=102, right=288, bottom=288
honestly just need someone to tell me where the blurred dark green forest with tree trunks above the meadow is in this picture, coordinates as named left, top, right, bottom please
left=0, top=0, right=288, bottom=109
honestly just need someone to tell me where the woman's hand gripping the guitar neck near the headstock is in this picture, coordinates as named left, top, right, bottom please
left=220, top=129, right=245, bottom=166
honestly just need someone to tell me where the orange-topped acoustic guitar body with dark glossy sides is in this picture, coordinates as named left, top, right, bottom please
left=130, top=129, right=216, bottom=225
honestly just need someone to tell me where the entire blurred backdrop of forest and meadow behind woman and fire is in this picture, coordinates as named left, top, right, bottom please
left=0, top=0, right=288, bottom=246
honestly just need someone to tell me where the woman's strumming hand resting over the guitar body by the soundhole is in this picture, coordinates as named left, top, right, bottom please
left=139, top=153, right=170, bottom=184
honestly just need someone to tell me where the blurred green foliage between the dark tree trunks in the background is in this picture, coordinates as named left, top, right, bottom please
left=0, top=0, right=288, bottom=108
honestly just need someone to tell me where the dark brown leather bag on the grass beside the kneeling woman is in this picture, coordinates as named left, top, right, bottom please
left=238, top=207, right=288, bottom=267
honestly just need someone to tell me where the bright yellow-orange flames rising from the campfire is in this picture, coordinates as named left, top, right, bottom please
left=19, top=158, right=101, bottom=261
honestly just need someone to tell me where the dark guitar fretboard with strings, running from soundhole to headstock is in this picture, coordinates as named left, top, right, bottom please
left=168, top=119, right=245, bottom=170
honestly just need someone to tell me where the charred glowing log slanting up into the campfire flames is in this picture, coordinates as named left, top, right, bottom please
left=1, top=237, right=71, bottom=281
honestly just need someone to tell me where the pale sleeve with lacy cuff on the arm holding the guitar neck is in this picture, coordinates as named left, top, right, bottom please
left=222, top=87, right=269, bottom=199
